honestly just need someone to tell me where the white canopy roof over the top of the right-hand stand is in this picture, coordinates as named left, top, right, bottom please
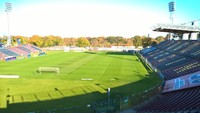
left=153, top=24, right=200, bottom=34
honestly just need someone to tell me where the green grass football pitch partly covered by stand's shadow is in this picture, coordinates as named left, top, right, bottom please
left=0, top=51, right=160, bottom=113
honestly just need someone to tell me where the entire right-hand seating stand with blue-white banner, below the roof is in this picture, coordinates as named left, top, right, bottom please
left=137, top=40, right=200, bottom=113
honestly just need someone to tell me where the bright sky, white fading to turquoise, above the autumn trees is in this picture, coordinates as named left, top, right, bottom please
left=0, top=0, right=200, bottom=38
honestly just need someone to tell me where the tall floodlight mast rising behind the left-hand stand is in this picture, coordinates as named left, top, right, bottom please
left=5, top=2, right=12, bottom=46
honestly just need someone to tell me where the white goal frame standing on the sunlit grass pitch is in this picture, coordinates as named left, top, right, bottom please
left=38, top=67, right=60, bottom=74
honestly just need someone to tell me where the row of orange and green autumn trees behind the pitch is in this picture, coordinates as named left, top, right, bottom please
left=0, top=35, right=165, bottom=47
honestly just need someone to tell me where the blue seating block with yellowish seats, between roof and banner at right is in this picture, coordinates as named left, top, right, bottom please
left=141, top=41, right=200, bottom=80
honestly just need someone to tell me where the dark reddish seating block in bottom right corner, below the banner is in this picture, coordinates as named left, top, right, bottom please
left=138, top=87, right=200, bottom=113
